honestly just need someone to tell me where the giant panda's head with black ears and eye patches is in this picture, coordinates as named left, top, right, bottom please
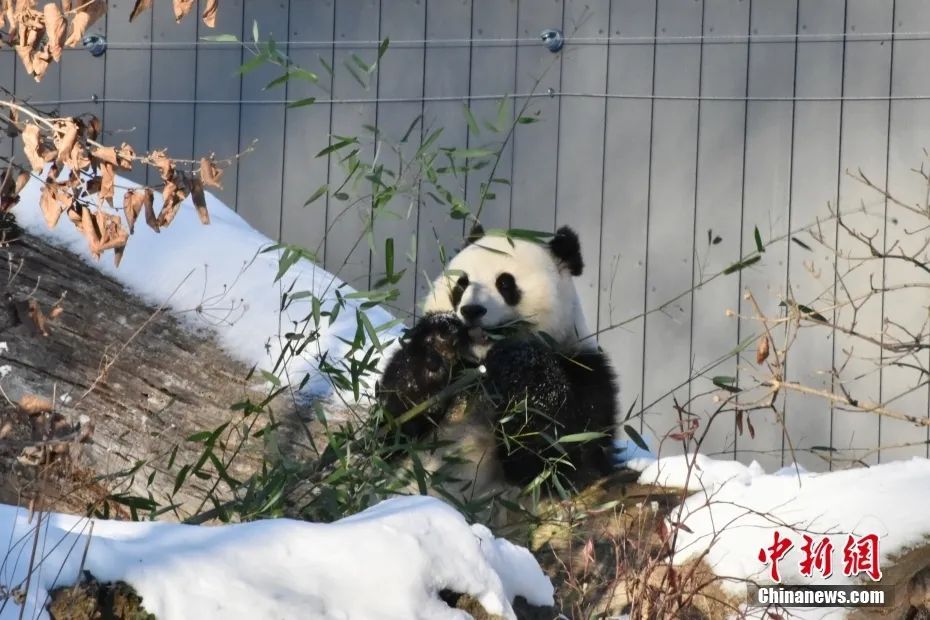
left=424, top=226, right=588, bottom=348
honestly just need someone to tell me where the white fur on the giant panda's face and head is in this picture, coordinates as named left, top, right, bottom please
left=423, top=235, right=597, bottom=351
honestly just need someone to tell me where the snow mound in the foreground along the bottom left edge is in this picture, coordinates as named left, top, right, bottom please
left=0, top=496, right=553, bottom=620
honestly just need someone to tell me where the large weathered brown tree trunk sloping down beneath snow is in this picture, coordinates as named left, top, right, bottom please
left=0, top=224, right=280, bottom=518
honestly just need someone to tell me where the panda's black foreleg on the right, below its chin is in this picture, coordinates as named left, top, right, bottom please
left=485, top=340, right=617, bottom=486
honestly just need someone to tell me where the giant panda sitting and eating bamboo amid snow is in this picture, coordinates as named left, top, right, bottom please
left=376, top=226, right=618, bottom=516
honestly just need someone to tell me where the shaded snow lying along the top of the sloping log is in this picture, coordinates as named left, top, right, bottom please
left=13, top=172, right=400, bottom=395
